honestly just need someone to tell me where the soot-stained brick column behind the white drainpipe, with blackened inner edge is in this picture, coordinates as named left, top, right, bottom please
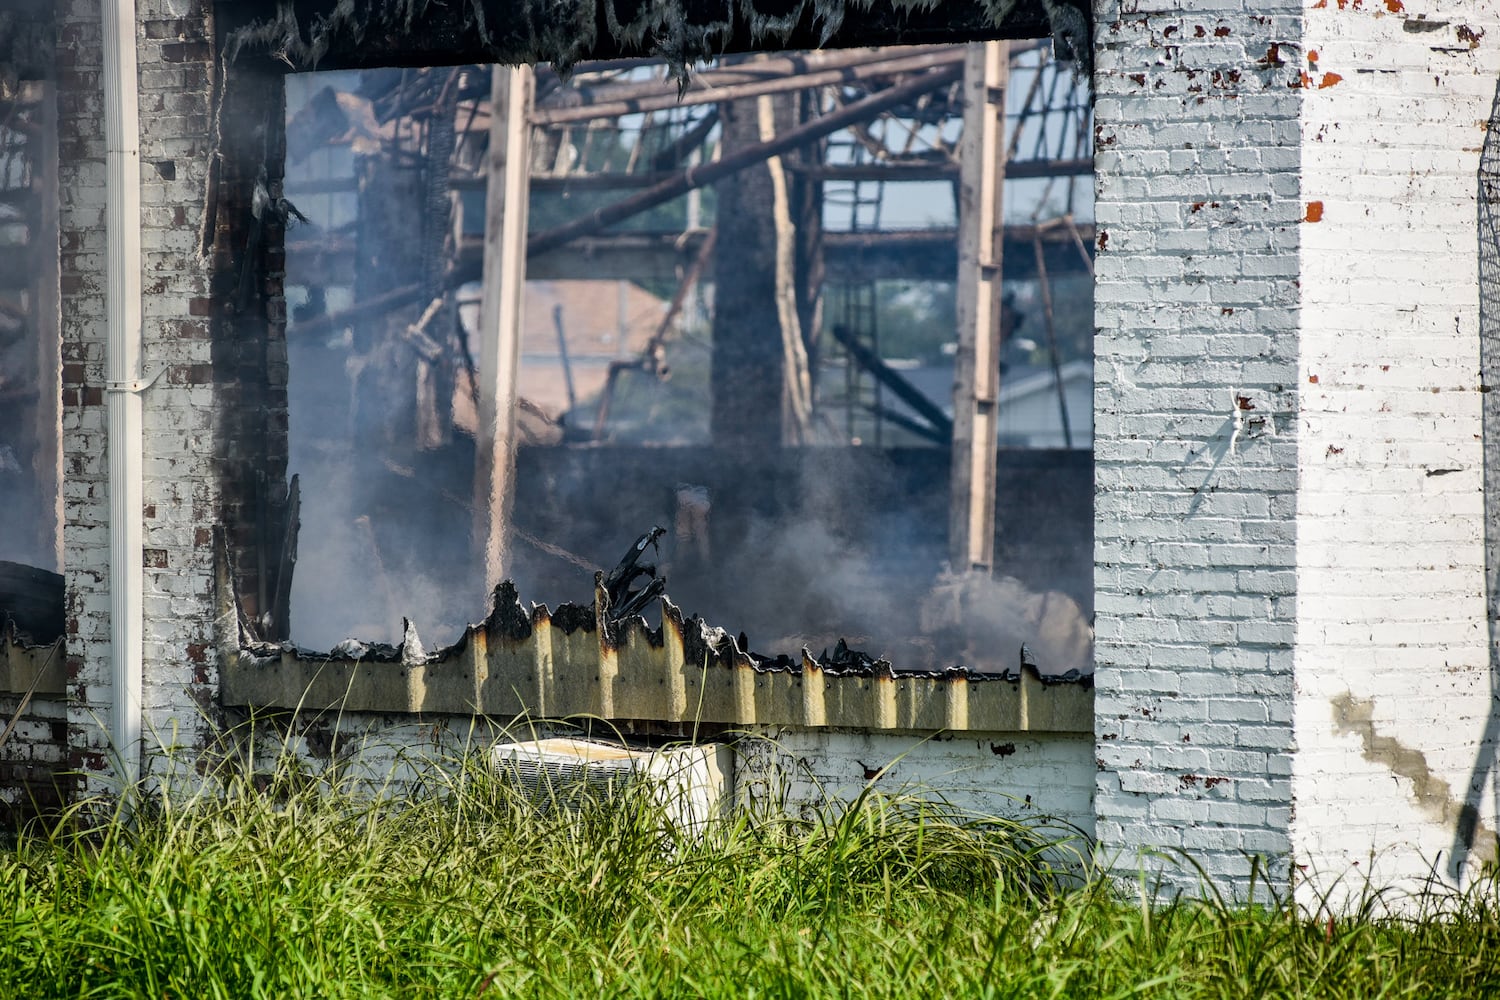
left=59, top=0, right=287, bottom=789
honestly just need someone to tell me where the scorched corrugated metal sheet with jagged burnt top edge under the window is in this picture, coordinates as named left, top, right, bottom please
left=221, top=582, right=1094, bottom=733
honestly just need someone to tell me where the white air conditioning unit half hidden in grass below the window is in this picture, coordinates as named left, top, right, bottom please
left=489, top=738, right=734, bottom=835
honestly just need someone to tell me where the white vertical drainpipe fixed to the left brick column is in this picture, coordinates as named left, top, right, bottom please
left=102, top=0, right=144, bottom=792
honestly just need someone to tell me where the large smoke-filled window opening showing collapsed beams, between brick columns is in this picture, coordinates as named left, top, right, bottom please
left=287, top=42, right=1094, bottom=673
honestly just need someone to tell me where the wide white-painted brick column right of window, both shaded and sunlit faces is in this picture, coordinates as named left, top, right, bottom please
left=1095, top=0, right=1500, bottom=905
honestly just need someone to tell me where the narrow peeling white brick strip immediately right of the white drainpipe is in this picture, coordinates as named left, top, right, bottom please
left=137, top=0, right=224, bottom=773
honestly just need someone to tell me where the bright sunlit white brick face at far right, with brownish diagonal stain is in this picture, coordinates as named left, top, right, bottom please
left=1292, top=0, right=1500, bottom=898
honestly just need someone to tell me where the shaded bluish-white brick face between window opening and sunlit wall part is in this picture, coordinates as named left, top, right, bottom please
left=1095, top=0, right=1304, bottom=888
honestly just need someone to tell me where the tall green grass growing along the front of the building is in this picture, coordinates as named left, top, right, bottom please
left=0, top=749, right=1500, bottom=999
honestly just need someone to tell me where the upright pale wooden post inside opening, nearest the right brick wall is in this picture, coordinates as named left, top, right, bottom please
left=948, top=42, right=1010, bottom=571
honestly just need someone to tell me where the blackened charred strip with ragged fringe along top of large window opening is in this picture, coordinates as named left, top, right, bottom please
left=218, top=0, right=1092, bottom=84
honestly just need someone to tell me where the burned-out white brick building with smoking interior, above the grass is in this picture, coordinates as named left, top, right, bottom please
left=0, top=0, right=1500, bottom=905
